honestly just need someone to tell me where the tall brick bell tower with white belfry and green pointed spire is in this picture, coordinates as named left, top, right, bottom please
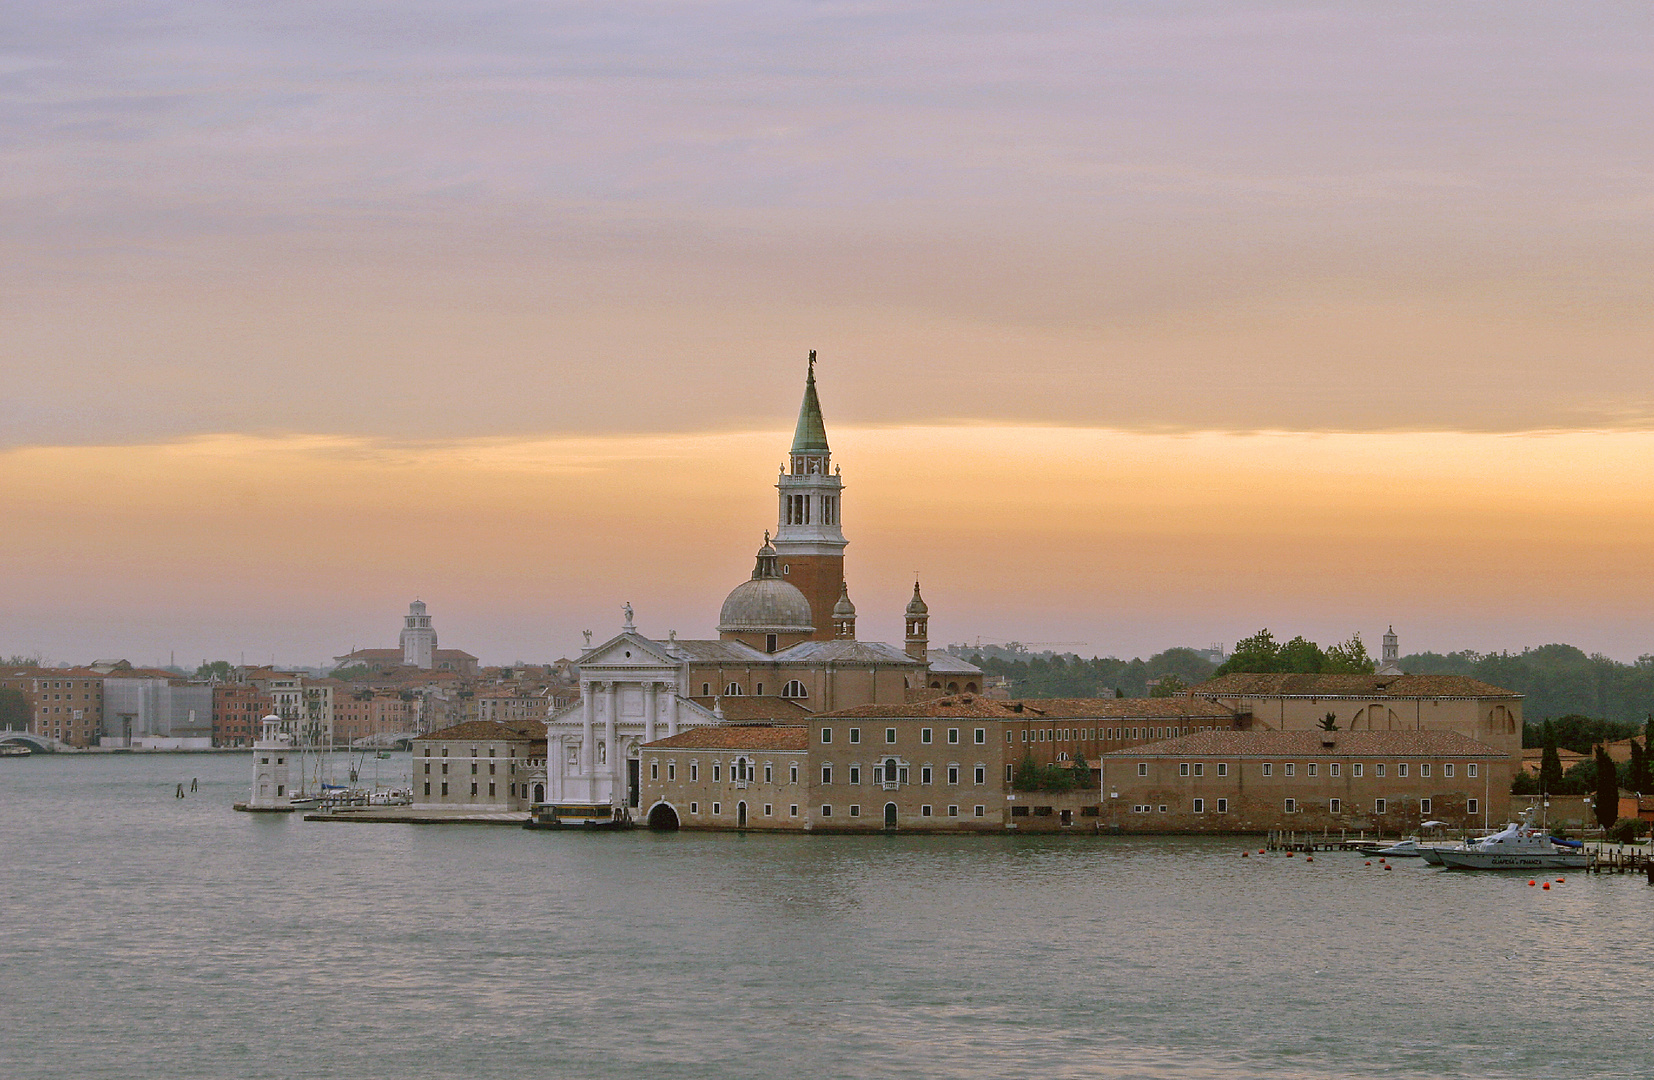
left=776, top=349, right=849, bottom=642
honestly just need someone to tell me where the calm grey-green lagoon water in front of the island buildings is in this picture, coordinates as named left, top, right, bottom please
left=0, top=754, right=1654, bottom=1080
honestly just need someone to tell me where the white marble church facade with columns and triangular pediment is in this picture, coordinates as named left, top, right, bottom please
left=546, top=612, right=718, bottom=805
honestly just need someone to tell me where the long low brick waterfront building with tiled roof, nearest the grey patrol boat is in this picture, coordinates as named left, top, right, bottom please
left=1102, top=729, right=1513, bottom=834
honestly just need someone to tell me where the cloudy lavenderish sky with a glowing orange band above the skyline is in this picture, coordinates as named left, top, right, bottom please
left=0, top=0, right=1654, bottom=663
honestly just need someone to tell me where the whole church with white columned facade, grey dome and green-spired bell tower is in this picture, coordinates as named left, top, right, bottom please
left=546, top=351, right=982, bottom=805
